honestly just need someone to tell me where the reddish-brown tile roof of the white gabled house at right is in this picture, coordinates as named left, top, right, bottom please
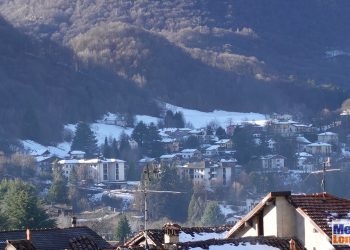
left=289, top=193, right=350, bottom=238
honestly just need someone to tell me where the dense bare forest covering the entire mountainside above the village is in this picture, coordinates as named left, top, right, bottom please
left=0, top=0, right=350, bottom=143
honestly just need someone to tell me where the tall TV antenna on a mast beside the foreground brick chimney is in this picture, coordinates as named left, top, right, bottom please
left=142, top=164, right=183, bottom=249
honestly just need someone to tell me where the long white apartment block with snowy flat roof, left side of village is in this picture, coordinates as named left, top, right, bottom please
left=58, top=158, right=126, bottom=183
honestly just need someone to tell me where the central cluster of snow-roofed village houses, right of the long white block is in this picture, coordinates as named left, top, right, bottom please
left=138, top=128, right=240, bottom=187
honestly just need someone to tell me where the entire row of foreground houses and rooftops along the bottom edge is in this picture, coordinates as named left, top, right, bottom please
left=0, top=191, right=350, bottom=250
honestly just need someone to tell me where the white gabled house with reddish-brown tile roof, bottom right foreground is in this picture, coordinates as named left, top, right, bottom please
left=225, top=192, right=350, bottom=250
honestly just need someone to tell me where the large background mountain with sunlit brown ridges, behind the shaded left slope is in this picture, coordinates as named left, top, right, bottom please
left=0, top=0, right=350, bottom=113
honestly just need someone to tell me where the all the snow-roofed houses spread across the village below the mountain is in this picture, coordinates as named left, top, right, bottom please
left=23, top=111, right=350, bottom=189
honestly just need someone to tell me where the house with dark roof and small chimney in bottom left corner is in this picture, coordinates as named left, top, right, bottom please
left=0, top=226, right=114, bottom=250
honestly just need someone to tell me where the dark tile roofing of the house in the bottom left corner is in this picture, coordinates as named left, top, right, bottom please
left=0, top=227, right=111, bottom=250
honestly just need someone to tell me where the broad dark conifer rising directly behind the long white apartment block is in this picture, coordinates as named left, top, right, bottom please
left=71, top=122, right=98, bottom=157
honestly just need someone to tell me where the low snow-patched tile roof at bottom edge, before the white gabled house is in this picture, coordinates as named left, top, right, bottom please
left=177, top=236, right=305, bottom=250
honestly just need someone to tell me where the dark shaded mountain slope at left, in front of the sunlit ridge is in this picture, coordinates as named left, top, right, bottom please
left=0, top=18, right=159, bottom=143
